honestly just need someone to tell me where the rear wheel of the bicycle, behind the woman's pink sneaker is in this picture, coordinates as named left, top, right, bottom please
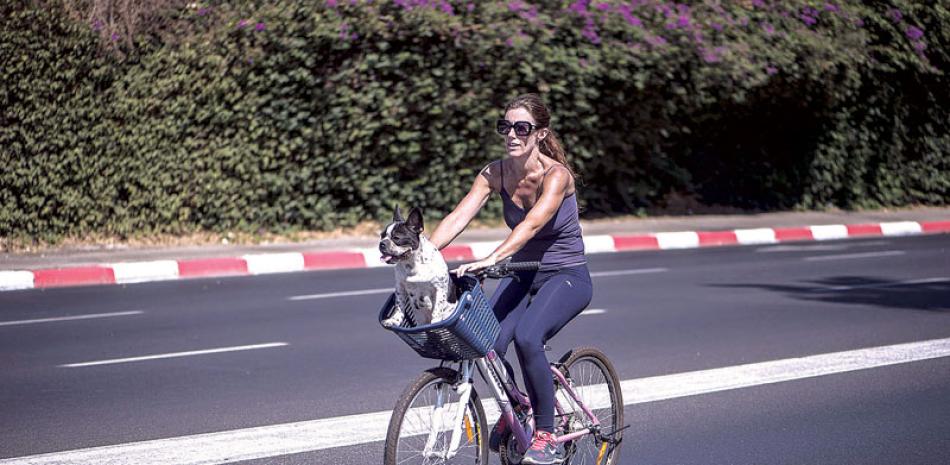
left=555, top=347, right=623, bottom=465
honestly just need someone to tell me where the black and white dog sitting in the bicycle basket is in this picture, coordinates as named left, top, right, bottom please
left=379, top=206, right=456, bottom=327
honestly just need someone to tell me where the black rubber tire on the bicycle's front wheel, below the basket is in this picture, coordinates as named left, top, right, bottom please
left=383, top=367, right=488, bottom=465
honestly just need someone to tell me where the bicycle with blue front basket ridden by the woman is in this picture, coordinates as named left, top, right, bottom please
left=379, top=262, right=629, bottom=465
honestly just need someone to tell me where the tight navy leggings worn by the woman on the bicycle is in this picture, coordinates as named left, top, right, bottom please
left=491, top=265, right=593, bottom=432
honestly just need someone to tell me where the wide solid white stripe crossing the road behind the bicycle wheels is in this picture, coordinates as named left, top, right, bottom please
left=13, top=338, right=950, bottom=465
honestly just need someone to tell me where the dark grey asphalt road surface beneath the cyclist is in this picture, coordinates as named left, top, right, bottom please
left=0, top=235, right=950, bottom=465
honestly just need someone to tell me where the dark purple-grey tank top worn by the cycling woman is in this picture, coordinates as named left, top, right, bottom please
left=499, top=163, right=587, bottom=271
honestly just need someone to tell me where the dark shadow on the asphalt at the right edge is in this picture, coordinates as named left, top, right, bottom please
left=713, top=276, right=950, bottom=312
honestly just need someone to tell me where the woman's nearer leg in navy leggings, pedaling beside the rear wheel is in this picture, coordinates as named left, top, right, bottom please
left=515, top=266, right=593, bottom=432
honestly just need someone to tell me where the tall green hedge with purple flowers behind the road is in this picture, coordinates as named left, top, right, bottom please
left=0, top=0, right=950, bottom=240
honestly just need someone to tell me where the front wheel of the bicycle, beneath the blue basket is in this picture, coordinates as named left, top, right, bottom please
left=383, top=367, right=488, bottom=465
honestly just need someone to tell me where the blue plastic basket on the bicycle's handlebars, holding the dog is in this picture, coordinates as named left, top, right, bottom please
left=379, top=276, right=499, bottom=361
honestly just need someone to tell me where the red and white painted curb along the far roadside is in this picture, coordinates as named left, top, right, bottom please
left=0, top=221, right=950, bottom=290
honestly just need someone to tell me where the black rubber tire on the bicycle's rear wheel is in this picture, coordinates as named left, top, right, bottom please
left=556, top=347, right=624, bottom=465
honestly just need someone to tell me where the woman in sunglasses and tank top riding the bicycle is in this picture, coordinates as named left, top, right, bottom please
left=429, top=94, right=593, bottom=465
